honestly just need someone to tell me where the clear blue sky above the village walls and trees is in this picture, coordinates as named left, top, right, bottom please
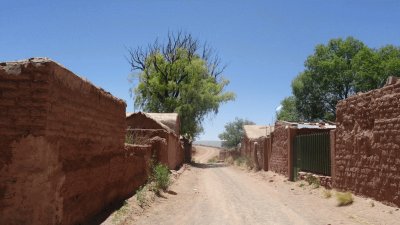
left=0, top=0, right=400, bottom=140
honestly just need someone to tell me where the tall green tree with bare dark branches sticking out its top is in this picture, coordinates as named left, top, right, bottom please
left=129, top=32, right=235, bottom=139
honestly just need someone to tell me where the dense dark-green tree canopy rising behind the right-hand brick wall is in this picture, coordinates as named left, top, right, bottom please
left=292, top=37, right=400, bottom=121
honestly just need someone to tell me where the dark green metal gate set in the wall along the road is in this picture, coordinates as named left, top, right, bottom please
left=293, top=132, right=331, bottom=180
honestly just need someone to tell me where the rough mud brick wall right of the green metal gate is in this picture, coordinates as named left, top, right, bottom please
left=333, top=79, right=400, bottom=206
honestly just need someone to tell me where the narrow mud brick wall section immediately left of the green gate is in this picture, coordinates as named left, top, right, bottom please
left=268, top=122, right=289, bottom=176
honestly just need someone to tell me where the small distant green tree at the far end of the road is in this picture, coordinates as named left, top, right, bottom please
left=218, top=118, right=254, bottom=148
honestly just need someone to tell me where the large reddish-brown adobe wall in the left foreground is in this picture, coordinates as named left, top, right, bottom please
left=0, top=59, right=151, bottom=224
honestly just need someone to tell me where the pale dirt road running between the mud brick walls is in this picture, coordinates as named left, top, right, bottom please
left=125, top=147, right=400, bottom=225
